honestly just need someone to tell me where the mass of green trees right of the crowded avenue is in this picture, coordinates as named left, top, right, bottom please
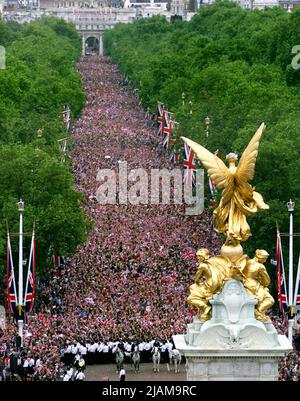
left=105, top=2, right=300, bottom=286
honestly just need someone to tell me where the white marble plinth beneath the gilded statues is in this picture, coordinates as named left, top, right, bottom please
left=173, top=279, right=292, bottom=381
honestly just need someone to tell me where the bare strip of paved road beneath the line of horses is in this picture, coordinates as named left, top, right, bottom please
left=85, top=363, right=186, bottom=381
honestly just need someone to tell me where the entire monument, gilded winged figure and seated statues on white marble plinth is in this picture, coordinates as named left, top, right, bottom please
left=178, top=123, right=292, bottom=381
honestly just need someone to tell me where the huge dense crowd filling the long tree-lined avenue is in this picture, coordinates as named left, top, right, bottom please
left=0, top=56, right=300, bottom=381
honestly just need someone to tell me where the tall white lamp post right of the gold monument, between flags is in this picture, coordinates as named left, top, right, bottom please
left=287, top=199, right=295, bottom=343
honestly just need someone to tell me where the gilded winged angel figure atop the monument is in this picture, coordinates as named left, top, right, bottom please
left=182, top=123, right=269, bottom=242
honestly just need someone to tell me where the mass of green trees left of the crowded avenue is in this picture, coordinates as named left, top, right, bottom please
left=0, top=18, right=90, bottom=273
